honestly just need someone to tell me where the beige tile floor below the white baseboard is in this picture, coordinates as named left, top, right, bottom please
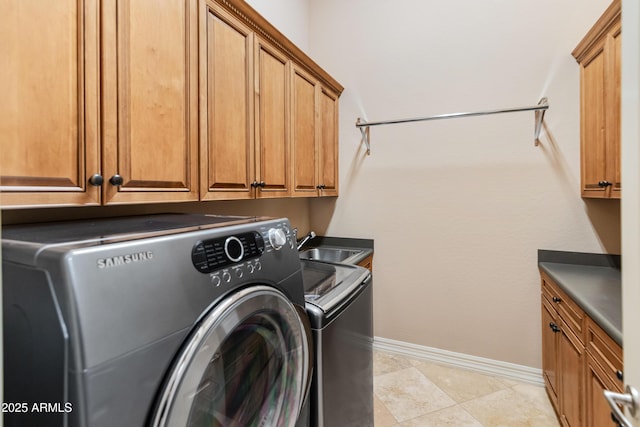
left=373, top=351, right=560, bottom=427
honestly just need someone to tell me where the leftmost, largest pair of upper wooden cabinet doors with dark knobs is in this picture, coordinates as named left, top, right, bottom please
left=0, top=0, right=198, bottom=207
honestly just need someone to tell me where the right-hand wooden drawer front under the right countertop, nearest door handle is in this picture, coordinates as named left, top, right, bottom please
left=586, top=317, right=624, bottom=392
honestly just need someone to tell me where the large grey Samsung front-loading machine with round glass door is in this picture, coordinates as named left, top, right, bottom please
left=2, top=214, right=313, bottom=427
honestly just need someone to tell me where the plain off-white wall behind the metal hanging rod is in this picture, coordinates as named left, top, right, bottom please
left=310, top=0, right=620, bottom=367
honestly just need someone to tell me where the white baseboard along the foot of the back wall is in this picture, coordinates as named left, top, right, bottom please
left=373, top=337, right=544, bottom=387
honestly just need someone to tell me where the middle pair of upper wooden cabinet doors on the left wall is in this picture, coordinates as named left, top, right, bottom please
left=201, top=4, right=291, bottom=200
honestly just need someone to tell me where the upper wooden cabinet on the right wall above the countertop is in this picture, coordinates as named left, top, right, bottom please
left=572, top=0, right=622, bottom=199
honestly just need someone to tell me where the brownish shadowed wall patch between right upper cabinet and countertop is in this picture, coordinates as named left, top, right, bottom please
left=583, top=199, right=622, bottom=255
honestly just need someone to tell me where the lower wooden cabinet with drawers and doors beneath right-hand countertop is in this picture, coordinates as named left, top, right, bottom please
left=541, top=273, right=623, bottom=427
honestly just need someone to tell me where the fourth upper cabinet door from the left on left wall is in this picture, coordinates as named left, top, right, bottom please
left=255, top=38, right=291, bottom=198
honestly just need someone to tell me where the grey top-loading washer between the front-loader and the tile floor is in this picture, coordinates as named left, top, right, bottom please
left=301, top=260, right=373, bottom=427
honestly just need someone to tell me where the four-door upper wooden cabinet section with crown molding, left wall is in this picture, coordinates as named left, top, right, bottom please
left=200, top=0, right=342, bottom=200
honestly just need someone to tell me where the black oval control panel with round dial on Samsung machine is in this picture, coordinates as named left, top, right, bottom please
left=191, top=231, right=265, bottom=273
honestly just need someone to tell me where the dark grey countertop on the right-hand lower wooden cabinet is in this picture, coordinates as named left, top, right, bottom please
left=538, top=250, right=622, bottom=346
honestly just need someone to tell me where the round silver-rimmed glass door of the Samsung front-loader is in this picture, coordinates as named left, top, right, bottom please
left=152, top=285, right=311, bottom=427
